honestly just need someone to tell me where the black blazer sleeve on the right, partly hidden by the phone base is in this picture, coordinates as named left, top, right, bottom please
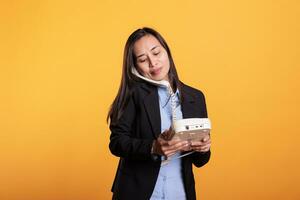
left=190, top=91, right=211, bottom=167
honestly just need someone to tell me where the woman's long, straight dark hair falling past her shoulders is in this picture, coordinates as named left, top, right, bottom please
left=106, top=27, right=181, bottom=123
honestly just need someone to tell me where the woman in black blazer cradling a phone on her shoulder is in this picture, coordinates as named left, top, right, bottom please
left=108, top=28, right=210, bottom=200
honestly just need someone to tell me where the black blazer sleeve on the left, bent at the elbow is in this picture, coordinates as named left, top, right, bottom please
left=109, top=93, right=153, bottom=160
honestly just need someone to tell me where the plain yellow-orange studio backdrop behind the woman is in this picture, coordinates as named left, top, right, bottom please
left=0, top=0, right=300, bottom=200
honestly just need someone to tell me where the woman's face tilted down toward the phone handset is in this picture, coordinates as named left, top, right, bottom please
left=133, top=35, right=170, bottom=81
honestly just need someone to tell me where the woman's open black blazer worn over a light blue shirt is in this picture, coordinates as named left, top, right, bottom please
left=109, top=82, right=210, bottom=200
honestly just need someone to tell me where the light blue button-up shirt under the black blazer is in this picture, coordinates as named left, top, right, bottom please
left=150, top=87, right=186, bottom=200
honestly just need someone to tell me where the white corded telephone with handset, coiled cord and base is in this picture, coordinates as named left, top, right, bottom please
left=131, top=67, right=211, bottom=165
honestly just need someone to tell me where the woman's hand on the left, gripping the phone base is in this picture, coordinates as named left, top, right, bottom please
left=152, top=129, right=189, bottom=157
